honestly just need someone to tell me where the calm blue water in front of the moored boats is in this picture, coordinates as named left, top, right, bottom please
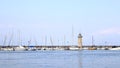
left=0, top=50, right=120, bottom=68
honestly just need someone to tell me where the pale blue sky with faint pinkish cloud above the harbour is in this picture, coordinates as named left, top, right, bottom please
left=0, top=0, right=120, bottom=45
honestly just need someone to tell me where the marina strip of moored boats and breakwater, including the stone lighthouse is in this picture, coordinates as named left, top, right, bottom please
left=0, top=33, right=120, bottom=51
